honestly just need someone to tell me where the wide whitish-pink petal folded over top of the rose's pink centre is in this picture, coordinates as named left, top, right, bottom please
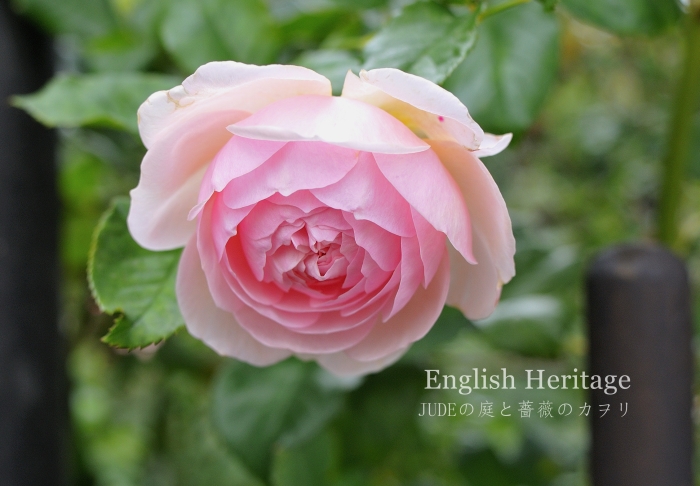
left=228, top=95, right=428, bottom=154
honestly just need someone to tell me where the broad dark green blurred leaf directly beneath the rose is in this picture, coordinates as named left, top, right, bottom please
left=212, top=360, right=343, bottom=478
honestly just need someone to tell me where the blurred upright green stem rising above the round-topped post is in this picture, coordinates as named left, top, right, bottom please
left=657, top=7, right=700, bottom=250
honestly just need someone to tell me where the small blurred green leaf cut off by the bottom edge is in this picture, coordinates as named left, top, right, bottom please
left=272, top=431, right=338, bottom=486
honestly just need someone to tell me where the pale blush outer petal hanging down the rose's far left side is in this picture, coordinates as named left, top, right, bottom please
left=127, top=111, right=247, bottom=250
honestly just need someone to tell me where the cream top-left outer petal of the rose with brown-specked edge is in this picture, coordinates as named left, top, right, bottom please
left=138, top=61, right=331, bottom=148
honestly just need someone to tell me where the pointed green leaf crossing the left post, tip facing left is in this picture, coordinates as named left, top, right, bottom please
left=12, top=73, right=179, bottom=133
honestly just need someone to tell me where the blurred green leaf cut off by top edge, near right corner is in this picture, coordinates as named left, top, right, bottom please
left=561, top=0, right=682, bottom=35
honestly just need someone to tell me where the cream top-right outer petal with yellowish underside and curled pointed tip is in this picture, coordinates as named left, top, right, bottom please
left=342, top=68, right=512, bottom=156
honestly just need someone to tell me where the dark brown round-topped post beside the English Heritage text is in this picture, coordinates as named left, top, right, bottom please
left=587, top=245, right=693, bottom=486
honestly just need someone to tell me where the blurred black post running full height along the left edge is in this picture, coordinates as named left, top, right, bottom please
left=0, top=0, right=67, bottom=486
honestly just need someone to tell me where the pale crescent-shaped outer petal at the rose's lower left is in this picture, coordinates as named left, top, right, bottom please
left=176, top=234, right=291, bottom=366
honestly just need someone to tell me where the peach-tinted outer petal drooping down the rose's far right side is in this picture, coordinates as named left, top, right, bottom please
left=431, top=142, right=515, bottom=319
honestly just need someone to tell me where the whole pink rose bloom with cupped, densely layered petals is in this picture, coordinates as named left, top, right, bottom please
left=128, top=62, right=515, bottom=375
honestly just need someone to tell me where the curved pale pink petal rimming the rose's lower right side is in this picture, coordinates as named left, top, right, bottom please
left=345, top=252, right=450, bottom=361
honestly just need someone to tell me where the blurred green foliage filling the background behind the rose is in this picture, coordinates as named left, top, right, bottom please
left=8, top=0, right=700, bottom=486
